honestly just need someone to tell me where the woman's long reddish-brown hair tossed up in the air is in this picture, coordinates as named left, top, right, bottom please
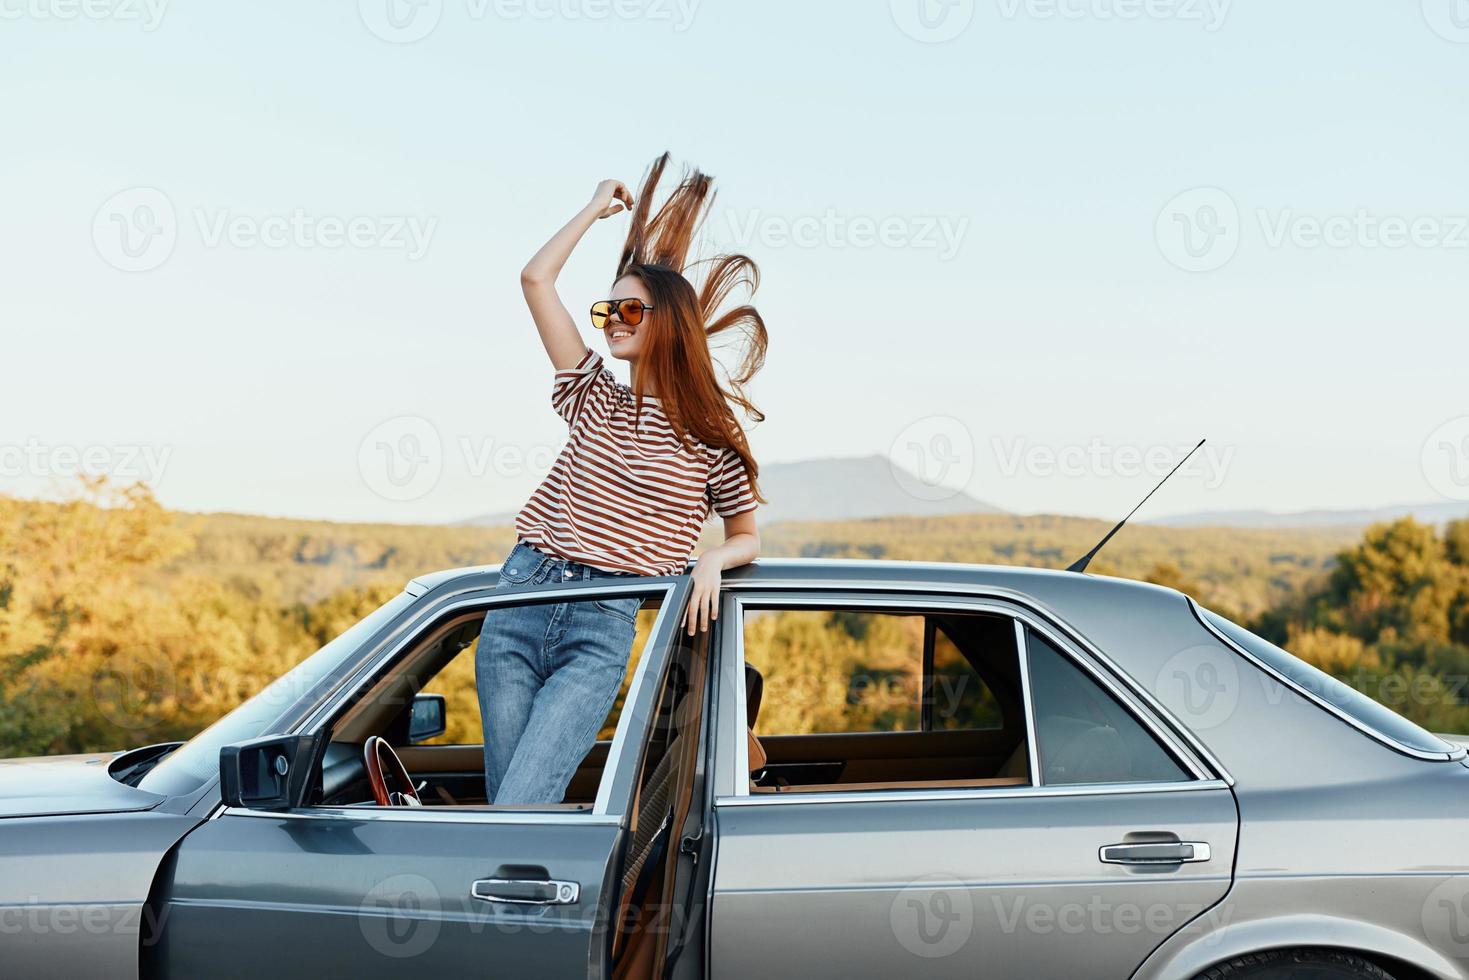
left=617, top=153, right=768, bottom=502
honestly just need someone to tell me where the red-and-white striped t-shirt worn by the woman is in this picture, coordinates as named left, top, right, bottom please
left=516, top=350, right=757, bottom=574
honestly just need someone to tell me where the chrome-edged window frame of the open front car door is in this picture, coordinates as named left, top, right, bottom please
left=210, top=576, right=689, bottom=826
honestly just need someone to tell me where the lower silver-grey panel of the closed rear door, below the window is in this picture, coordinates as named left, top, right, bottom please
left=711, top=783, right=1237, bottom=980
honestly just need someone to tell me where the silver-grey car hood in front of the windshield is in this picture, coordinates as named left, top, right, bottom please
left=0, top=752, right=163, bottom=818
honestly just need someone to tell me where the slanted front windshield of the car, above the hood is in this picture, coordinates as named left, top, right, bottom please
left=138, top=592, right=413, bottom=796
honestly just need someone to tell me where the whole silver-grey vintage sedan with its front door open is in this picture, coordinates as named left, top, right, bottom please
left=0, top=560, right=1469, bottom=980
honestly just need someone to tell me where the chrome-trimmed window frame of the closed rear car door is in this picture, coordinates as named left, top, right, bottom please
left=715, top=583, right=1232, bottom=807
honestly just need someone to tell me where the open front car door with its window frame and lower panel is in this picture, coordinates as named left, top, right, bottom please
left=144, top=576, right=689, bottom=980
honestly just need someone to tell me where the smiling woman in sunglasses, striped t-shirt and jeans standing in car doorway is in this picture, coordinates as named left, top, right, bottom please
left=474, top=153, right=765, bottom=805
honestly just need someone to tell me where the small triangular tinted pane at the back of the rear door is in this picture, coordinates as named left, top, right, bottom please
left=1025, top=633, right=1188, bottom=786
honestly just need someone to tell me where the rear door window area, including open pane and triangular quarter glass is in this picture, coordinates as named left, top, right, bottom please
left=743, top=607, right=1187, bottom=795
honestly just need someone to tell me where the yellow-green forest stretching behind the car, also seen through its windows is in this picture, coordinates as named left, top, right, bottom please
left=0, top=482, right=1469, bottom=758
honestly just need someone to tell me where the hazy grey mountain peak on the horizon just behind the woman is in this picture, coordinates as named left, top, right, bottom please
left=461, top=455, right=1005, bottom=527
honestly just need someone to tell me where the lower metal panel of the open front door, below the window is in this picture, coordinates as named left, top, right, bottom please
left=151, top=813, right=620, bottom=980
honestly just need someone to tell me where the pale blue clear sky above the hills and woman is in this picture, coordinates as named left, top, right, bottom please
left=0, top=0, right=1469, bottom=522
